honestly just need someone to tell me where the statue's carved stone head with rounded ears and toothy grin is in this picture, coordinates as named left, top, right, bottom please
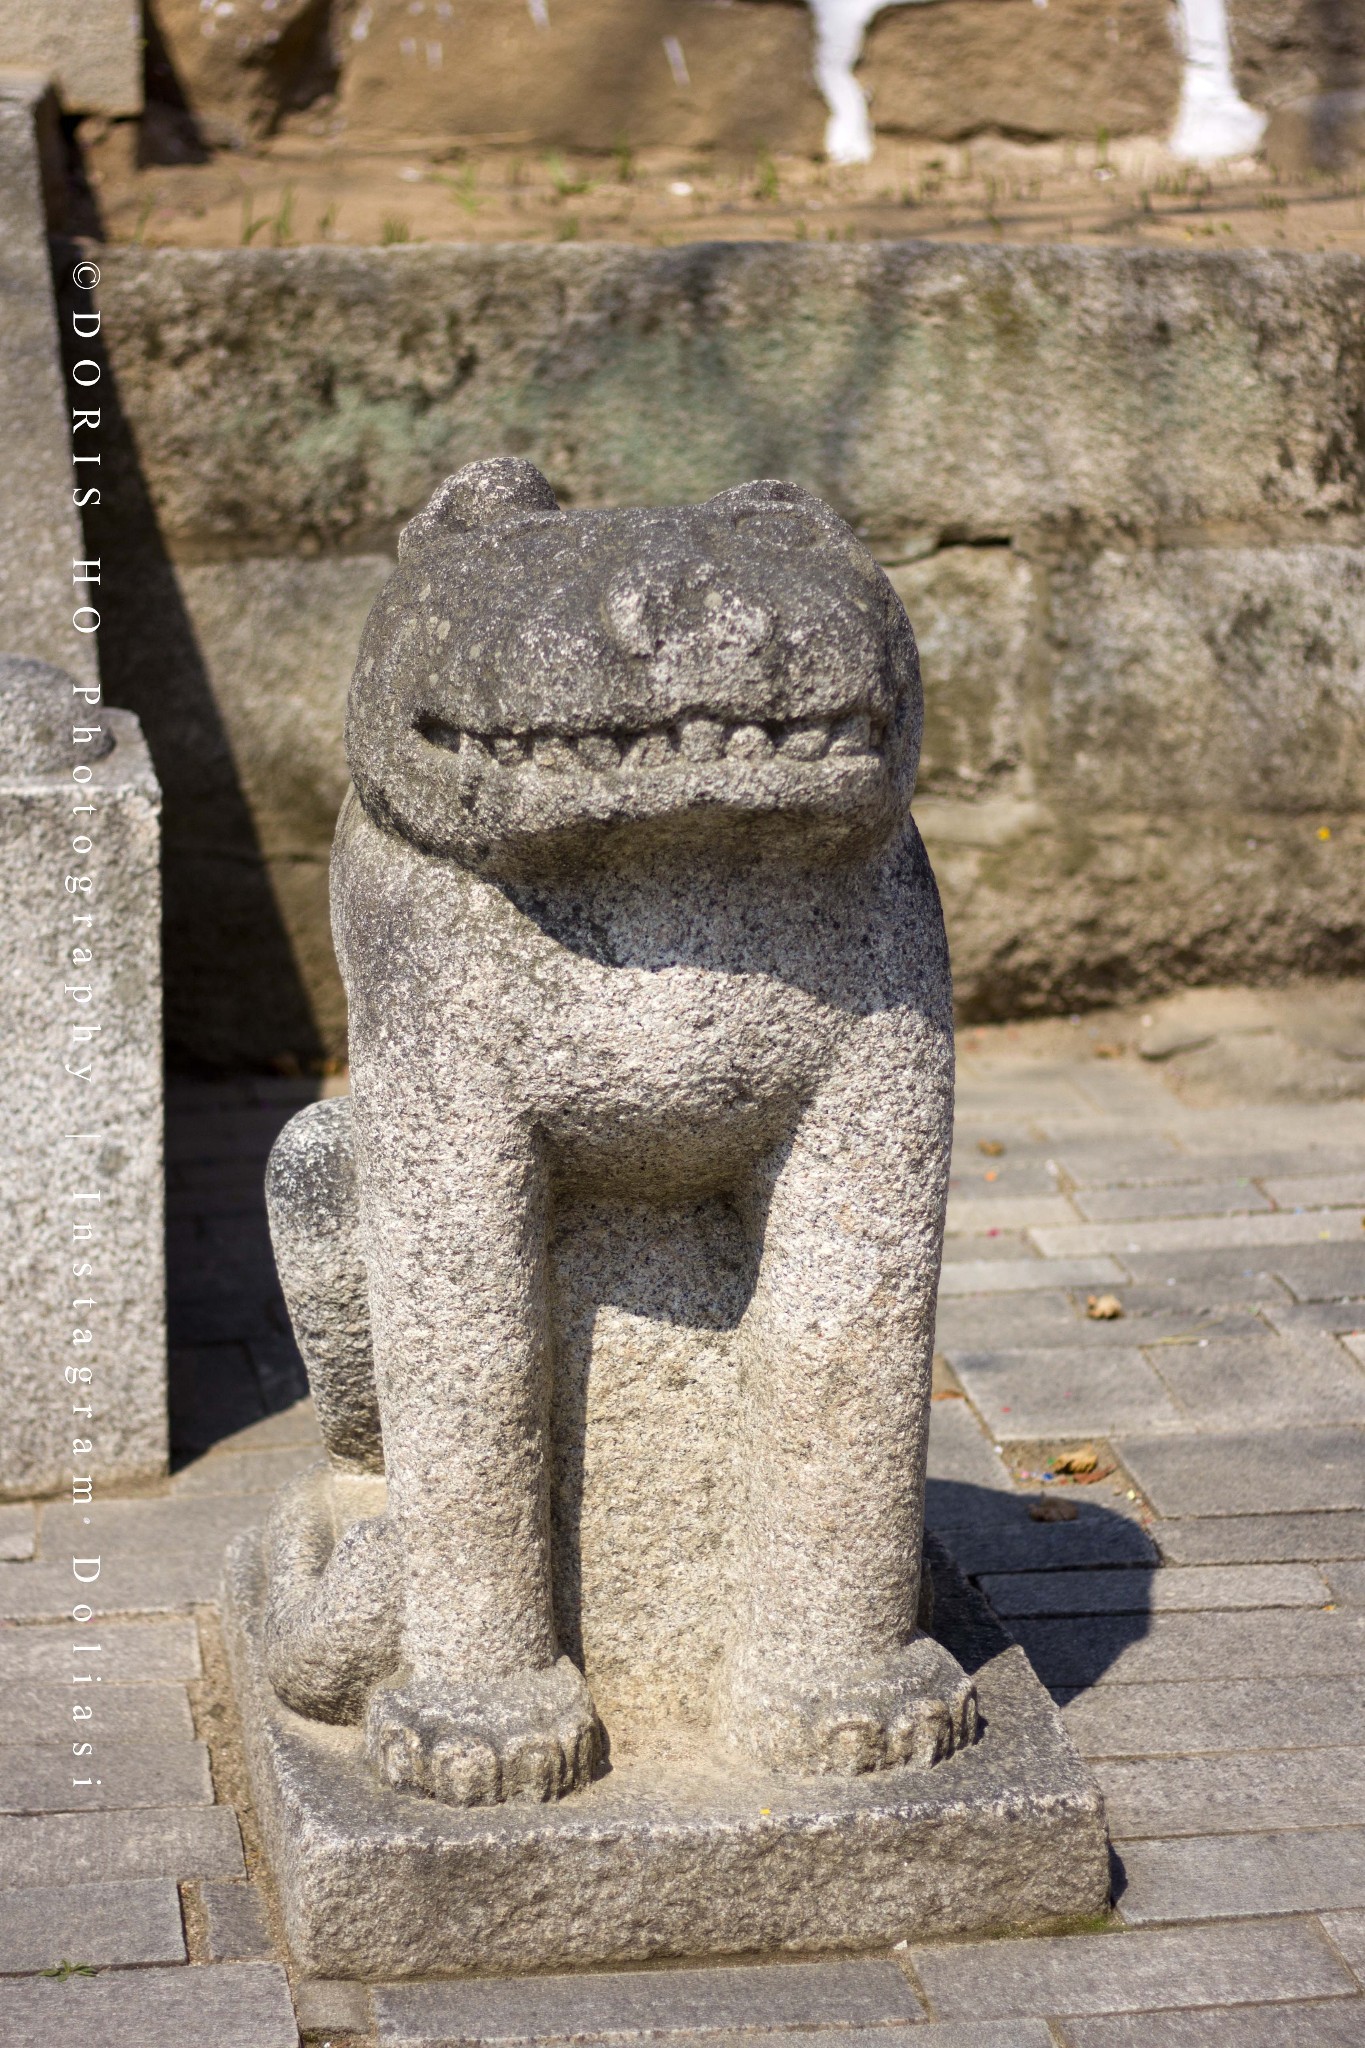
left=346, top=459, right=921, bottom=877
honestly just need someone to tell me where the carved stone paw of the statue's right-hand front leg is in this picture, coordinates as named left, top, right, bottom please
left=733, top=1636, right=980, bottom=1778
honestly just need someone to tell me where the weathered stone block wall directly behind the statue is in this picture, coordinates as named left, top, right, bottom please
left=77, top=244, right=1365, bottom=1063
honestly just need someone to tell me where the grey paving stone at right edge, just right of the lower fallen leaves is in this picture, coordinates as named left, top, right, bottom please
left=1115, top=1430, right=1365, bottom=1516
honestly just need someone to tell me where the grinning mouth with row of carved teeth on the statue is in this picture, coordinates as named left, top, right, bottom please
left=415, top=711, right=886, bottom=774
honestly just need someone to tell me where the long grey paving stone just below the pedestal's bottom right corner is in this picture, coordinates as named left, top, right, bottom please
left=909, top=1921, right=1357, bottom=2042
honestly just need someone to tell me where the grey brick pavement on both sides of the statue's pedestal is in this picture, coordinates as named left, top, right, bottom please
left=0, top=1059, right=1365, bottom=2048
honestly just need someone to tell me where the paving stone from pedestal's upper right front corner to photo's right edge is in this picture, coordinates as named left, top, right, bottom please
left=1095, top=1724, right=1365, bottom=1841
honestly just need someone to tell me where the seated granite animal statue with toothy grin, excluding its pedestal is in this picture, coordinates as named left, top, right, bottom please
left=266, top=459, right=976, bottom=1804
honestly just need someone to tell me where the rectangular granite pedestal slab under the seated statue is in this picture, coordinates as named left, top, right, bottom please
left=218, top=1534, right=1109, bottom=1980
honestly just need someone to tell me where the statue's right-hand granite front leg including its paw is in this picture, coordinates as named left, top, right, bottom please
left=729, top=1018, right=976, bottom=1772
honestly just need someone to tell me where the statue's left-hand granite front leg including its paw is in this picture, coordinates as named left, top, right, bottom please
left=354, top=1064, right=600, bottom=1804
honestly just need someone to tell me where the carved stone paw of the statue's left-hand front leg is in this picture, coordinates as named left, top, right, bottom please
left=366, top=1657, right=602, bottom=1806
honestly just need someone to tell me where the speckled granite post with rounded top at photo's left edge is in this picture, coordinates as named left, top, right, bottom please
left=0, top=655, right=166, bottom=1490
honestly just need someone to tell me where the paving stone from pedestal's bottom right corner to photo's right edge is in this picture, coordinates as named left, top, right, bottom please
left=1115, top=1827, right=1365, bottom=1925
